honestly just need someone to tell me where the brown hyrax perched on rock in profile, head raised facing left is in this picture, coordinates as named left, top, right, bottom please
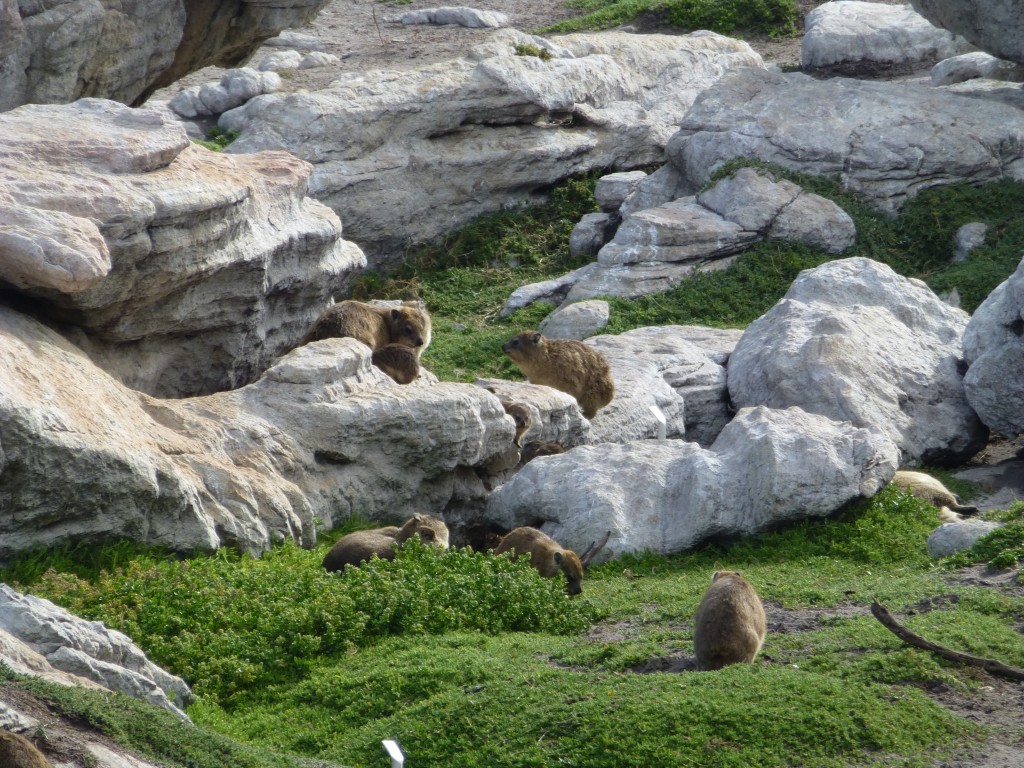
left=502, top=331, right=615, bottom=419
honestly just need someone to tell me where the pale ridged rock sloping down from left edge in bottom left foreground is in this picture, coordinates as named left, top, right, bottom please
left=0, top=584, right=195, bottom=720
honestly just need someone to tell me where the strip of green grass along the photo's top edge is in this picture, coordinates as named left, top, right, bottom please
left=539, top=0, right=799, bottom=37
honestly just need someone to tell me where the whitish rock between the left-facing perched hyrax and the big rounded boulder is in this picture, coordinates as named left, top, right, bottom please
left=587, top=326, right=741, bottom=445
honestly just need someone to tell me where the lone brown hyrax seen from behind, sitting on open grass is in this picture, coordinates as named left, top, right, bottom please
left=693, top=570, right=767, bottom=670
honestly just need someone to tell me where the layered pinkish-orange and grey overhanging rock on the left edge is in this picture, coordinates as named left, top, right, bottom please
left=0, top=99, right=366, bottom=396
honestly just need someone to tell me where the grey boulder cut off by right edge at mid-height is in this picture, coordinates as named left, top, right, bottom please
left=964, top=252, right=1024, bottom=436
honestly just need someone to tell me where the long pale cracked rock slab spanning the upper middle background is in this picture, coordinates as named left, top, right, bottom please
left=219, top=31, right=763, bottom=264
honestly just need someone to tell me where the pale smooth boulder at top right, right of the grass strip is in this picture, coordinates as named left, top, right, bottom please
left=800, top=0, right=974, bottom=77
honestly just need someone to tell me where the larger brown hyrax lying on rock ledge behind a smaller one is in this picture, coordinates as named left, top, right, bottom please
left=299, top=299, right=431, bottom=357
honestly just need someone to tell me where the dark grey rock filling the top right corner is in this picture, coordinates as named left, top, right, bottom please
left=910, top=0, right=1024, bottom=63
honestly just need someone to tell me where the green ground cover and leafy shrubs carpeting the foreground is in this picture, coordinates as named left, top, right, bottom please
left=0, top=489, right=1024, bottom=768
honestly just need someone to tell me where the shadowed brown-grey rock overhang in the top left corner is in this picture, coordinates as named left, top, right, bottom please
left=0, top=0, right=328, bottom=112
